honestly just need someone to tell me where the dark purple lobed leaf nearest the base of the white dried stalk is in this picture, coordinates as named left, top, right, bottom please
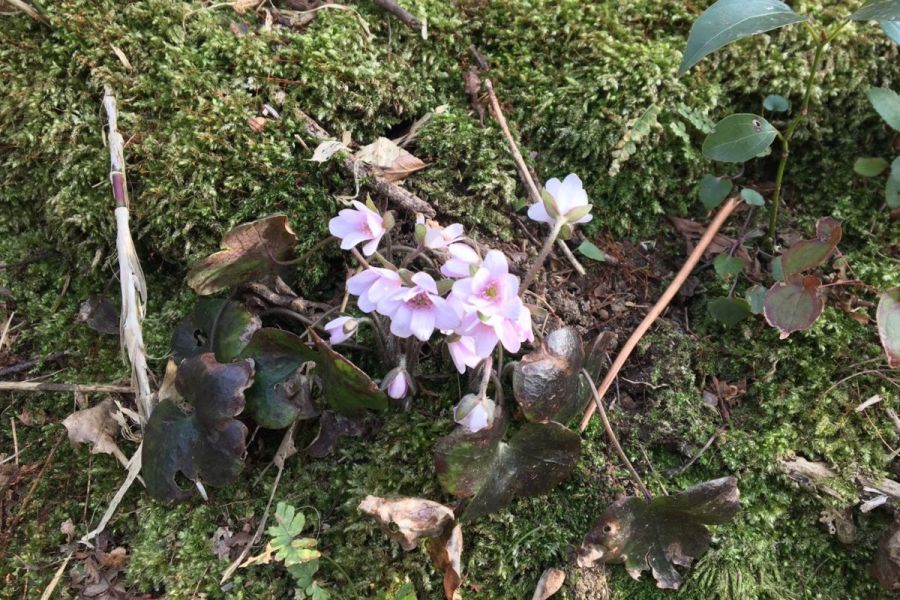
left=141, top=353, right=253, bottom=502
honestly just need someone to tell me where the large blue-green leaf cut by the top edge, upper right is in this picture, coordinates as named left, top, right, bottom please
left=678, top=0, right=806, bottom=75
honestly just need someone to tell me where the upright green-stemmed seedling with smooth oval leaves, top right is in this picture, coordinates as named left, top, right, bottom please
left=679, top=0, right=900, bottom=246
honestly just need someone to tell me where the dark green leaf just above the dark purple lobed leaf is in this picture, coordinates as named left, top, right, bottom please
left=172, top=299, right=262, bottom=363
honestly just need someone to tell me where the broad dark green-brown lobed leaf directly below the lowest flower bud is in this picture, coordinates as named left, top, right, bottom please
left=435, top=407, right=581, bottom=522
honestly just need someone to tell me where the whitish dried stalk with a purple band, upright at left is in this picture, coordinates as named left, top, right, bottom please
left=103, top=86, right=154, bottom=424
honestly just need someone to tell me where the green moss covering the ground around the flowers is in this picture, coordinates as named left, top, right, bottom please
left=0, top=0, right=900, bottom=600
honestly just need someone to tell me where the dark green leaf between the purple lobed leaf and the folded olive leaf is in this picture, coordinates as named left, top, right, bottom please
left=240, top=327, right=319, bottom=429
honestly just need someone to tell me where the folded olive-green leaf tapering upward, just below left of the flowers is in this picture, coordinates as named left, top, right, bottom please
left=309, top=330, right=387, bottom=416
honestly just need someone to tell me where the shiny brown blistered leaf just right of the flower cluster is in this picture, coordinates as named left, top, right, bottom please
left=513, top=327, right=584, bottom=423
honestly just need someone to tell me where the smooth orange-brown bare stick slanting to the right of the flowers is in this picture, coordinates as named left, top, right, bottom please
left=579, top=197, right=740, bottom=431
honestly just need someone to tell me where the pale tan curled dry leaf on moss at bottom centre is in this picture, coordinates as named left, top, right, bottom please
left=358, top=496, right=454, bottom=551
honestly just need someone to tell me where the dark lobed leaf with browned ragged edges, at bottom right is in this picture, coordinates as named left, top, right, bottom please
left=578, top=477, right=740, bottom=589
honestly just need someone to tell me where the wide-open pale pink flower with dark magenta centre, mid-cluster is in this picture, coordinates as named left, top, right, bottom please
left=378, top=272, right=459, bottom=342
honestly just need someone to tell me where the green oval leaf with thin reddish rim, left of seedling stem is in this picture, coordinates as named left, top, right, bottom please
left=703, top=113, right=778, bottom=162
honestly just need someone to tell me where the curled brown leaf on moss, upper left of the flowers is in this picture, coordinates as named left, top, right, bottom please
left=187, top=215, right=297, bottom=296
